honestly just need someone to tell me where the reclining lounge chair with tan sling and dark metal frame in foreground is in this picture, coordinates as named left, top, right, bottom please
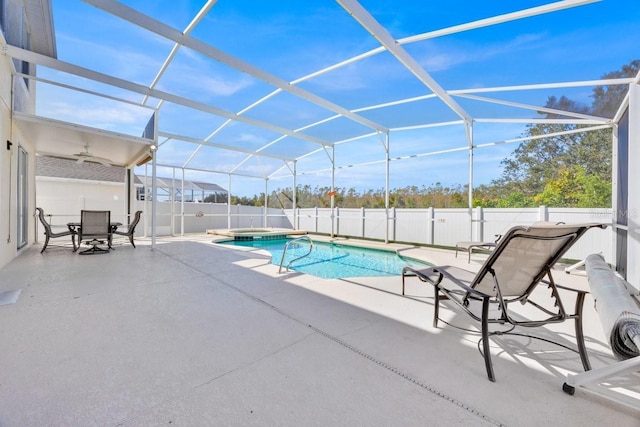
left=402, top=223, right=606, bottom=381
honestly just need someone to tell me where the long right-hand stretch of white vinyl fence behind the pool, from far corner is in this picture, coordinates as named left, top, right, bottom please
left=286, top=206, right=614, bottom=262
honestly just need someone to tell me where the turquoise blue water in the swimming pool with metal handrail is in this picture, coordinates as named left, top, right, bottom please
left=221, top=239, right=429, bottom=279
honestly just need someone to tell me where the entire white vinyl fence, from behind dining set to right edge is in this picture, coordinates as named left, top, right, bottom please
left=37, top=198, right=614, bottom=262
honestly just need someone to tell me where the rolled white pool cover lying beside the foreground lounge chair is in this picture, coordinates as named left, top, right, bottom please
left=585, top=254, right=640, bottom=360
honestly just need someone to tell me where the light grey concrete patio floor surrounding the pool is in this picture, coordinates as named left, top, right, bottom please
left=0, top=235, right=640, bottom=426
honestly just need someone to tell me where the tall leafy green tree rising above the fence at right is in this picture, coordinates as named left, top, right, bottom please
left=488, top=60, right=640, bottom=207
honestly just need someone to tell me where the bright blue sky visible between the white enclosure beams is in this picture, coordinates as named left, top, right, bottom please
left=38, top=0, right=640, bottom=195
